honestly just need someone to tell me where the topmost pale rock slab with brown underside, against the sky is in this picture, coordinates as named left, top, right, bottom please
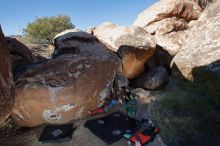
left=134, top=0, right=201, bottom=27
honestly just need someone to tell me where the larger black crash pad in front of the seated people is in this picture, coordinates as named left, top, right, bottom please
left=84, top=112, right=140, bottom=145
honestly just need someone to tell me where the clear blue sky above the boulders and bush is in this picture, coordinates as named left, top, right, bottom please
left=0, top=0, right=157, bottom=35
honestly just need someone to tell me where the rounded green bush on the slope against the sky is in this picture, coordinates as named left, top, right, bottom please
left=23, top=15, right=74, bottom=44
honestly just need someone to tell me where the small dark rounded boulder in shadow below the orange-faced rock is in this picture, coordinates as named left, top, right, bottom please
left=134, top=67, right=169, bottom=90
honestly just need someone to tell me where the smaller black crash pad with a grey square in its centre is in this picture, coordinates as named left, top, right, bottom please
left=39, top=124, right=76, bottom=143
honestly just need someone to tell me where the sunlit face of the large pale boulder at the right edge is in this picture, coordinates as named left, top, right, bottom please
left=173, top=1, right=220, bottom=79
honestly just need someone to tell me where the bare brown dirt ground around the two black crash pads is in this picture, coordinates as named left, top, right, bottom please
left=0, top=100, right=164, bottom=146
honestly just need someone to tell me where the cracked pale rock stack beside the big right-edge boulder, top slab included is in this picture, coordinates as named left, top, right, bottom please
left=134, top=0, right=202, bottom=56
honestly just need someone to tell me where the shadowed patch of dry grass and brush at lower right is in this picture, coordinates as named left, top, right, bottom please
left=150, top=70, right=220, bottom=146
